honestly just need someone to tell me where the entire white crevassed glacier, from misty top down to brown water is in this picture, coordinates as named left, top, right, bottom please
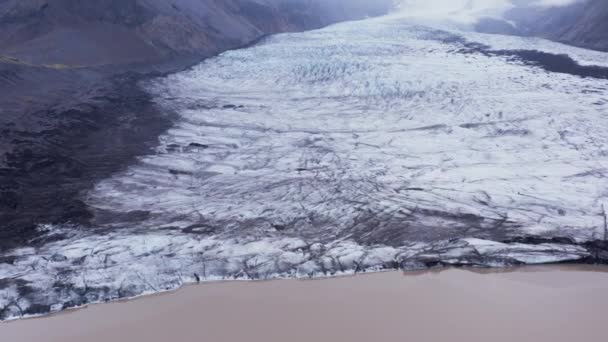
left=0, top=15, right=608, bottom=319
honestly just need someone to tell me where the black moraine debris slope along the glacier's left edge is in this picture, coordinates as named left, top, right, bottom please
left=0, top=75, right=171, bottom=250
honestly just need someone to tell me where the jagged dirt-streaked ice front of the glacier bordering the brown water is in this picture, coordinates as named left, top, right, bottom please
left=0, top=231, right=595, bottom=321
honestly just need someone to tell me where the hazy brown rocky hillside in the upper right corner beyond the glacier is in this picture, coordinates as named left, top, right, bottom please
left=506, top=0, right=608, bottom=51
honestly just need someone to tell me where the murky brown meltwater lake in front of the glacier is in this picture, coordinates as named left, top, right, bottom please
left=0, top=265, right=608, bottom=342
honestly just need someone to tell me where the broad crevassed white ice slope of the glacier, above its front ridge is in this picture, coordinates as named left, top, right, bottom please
left=90, top=17, right=608, bottom=245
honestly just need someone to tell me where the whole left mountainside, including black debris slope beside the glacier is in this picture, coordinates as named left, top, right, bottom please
left=0, top=0, right=392, bottom=250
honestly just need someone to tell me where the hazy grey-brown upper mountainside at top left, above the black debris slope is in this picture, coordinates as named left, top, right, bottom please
left=0, top=0, right=392, bottom=66
